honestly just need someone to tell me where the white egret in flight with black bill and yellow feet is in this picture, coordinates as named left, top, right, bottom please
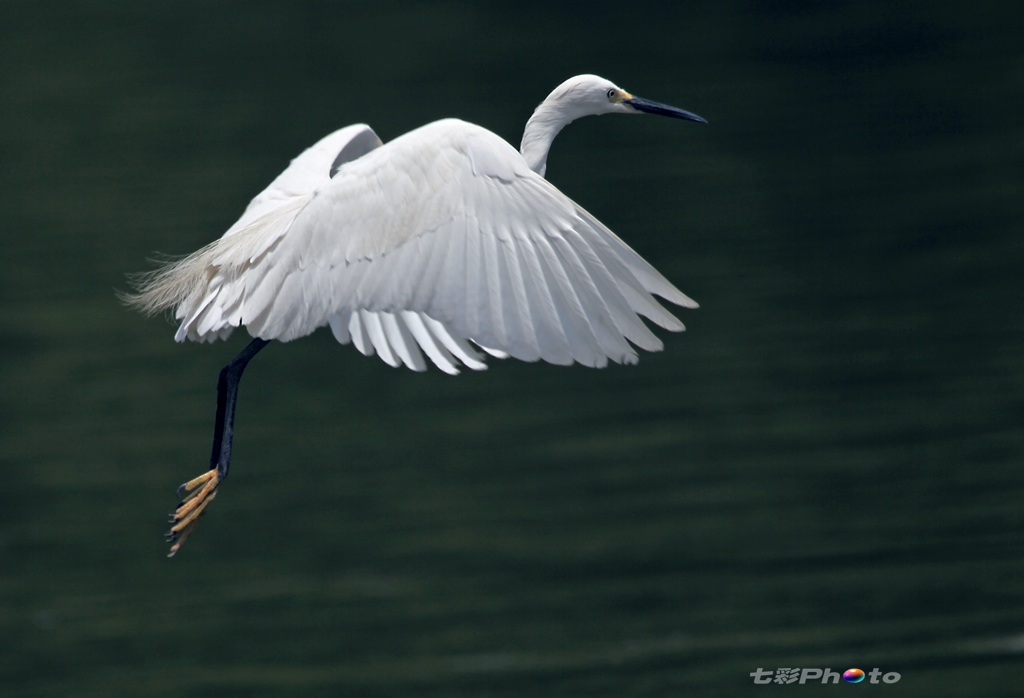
left=126, top=75, right=705, bottom=555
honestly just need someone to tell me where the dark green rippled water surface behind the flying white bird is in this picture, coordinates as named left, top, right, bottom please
left=0, top=1, right=1024, bottom=698
